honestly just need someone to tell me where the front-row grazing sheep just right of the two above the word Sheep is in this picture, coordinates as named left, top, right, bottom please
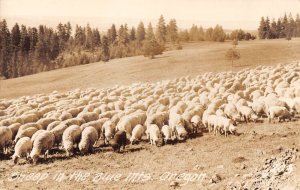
left=62, top=125, right=81, bottom=156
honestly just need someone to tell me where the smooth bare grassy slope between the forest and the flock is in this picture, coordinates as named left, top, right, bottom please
left=0, top=39, right=300, bottom=98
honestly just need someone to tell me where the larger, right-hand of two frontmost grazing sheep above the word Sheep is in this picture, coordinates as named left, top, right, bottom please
left=30, top=131, right=55, bottom=164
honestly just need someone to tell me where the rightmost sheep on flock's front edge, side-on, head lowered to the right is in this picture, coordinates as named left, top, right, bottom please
left=268, top=106, right=293, bottom=123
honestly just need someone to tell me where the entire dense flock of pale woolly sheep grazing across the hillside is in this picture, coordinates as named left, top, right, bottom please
left=0, top=63, right=300, bottom=163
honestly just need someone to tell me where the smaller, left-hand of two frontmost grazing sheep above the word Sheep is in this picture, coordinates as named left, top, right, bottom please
left=12, top=137, right=32, bottom=164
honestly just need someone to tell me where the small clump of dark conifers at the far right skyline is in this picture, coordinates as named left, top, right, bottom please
left=258, top=13, right=300, bottom=40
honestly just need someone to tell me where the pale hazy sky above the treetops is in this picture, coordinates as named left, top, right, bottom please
left=0, top=0, right=300, bottom=30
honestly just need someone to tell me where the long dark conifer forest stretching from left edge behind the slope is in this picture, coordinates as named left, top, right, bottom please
left=0, top=15, right=274, bottom=79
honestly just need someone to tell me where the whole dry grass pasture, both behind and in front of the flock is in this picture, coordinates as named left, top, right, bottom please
left=0, top=39, right=300, bottom=190
